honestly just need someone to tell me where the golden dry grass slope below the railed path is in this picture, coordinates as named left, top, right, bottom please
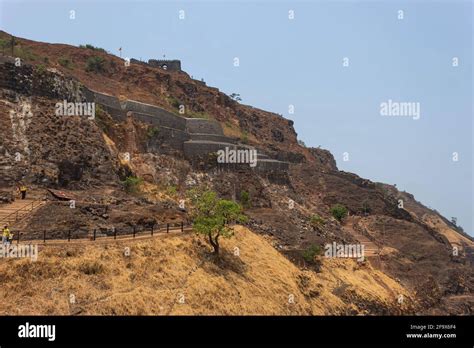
left=0, top=226, right=411, bottom=315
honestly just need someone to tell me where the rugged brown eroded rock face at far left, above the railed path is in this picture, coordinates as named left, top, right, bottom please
left=0, top=90, right=116, bottom=187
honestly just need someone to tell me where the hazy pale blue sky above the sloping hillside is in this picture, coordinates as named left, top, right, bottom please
left=0, top=0, right=474, bottom=235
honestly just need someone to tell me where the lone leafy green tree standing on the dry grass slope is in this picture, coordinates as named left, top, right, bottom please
left=188, top=189, right=247, bottom=256
